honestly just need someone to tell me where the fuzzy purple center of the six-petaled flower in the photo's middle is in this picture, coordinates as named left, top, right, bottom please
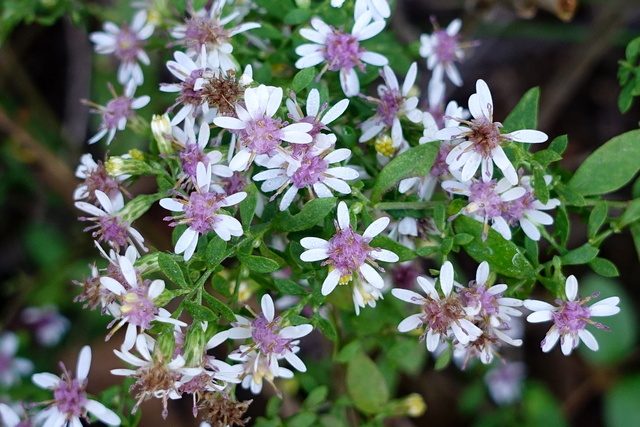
left=326, top=226, right=373, bottom=277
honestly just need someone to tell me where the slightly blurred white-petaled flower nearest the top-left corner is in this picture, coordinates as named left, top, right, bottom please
left=89, top=10, right=155, bottom=86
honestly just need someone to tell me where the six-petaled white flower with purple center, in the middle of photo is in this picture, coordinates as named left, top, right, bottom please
left=300, top=202, right=399, bottom=295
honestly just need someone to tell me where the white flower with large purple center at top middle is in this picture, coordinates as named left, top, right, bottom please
left=295, top=12, right=389, bottom=97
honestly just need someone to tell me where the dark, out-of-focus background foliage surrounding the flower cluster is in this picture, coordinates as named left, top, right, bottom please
left=0, top=0, right=640, bottom=427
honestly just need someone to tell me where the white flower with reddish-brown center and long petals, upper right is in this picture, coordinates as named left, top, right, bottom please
left=435, top=80, right=547, bottom=185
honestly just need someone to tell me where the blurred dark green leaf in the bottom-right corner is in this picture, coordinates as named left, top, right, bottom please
left=604, top=373, right=640, bottom=427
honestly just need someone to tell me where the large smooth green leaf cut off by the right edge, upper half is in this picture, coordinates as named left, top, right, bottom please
left=569, top=129, right=640, bottom=196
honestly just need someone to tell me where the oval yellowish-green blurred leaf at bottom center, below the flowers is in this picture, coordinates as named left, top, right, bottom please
left=346, top=353, right=389, bottom=414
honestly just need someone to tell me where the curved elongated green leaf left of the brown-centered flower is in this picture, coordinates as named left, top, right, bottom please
left=371, top=143, right=439, bottom=204
